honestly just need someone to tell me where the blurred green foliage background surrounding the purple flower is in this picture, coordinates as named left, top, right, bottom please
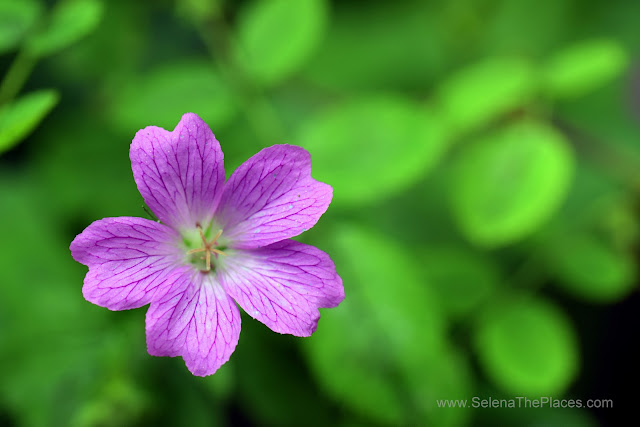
left=0, top=0, right=640, bottom=426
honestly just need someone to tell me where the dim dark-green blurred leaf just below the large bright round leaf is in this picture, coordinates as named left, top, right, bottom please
left=420, top=247, right=499, bottom=317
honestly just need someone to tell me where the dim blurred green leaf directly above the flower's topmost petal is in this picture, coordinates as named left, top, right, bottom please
left=110, top=61, right=236, bottom=134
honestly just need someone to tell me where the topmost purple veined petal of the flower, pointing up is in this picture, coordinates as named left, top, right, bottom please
left=129, top=113, right=224, bottom=229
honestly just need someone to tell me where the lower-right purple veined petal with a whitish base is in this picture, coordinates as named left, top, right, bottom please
left=218, top=240, right=344, bottom=337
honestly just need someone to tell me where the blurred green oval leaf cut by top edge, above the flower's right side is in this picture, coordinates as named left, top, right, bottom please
left=235, top=0, right=327, bottom=85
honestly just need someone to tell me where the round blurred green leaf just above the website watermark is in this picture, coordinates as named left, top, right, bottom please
left=474, top=297, right=580, bottom=398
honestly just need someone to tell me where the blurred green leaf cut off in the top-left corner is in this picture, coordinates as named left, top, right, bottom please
left=0, top=0, right=42, bottom=54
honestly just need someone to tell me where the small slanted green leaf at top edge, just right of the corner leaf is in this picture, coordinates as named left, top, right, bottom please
left=27, top=0, right=103, bottom=56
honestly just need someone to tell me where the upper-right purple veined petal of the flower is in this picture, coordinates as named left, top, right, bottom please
left=216, top=145, right=333, bottom=249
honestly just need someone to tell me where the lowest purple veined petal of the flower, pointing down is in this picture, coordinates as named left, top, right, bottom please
left=146, top=270, right=240, bottom=376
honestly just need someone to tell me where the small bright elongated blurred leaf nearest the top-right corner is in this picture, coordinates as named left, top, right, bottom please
left=545, top=40, right=629, bottom=97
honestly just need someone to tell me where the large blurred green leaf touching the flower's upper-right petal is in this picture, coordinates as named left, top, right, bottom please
left=296, top=96, right=447, bottom=204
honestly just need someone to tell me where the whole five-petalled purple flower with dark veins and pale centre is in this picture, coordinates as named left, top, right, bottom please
left=70, top=113, right=344, bottom=376
